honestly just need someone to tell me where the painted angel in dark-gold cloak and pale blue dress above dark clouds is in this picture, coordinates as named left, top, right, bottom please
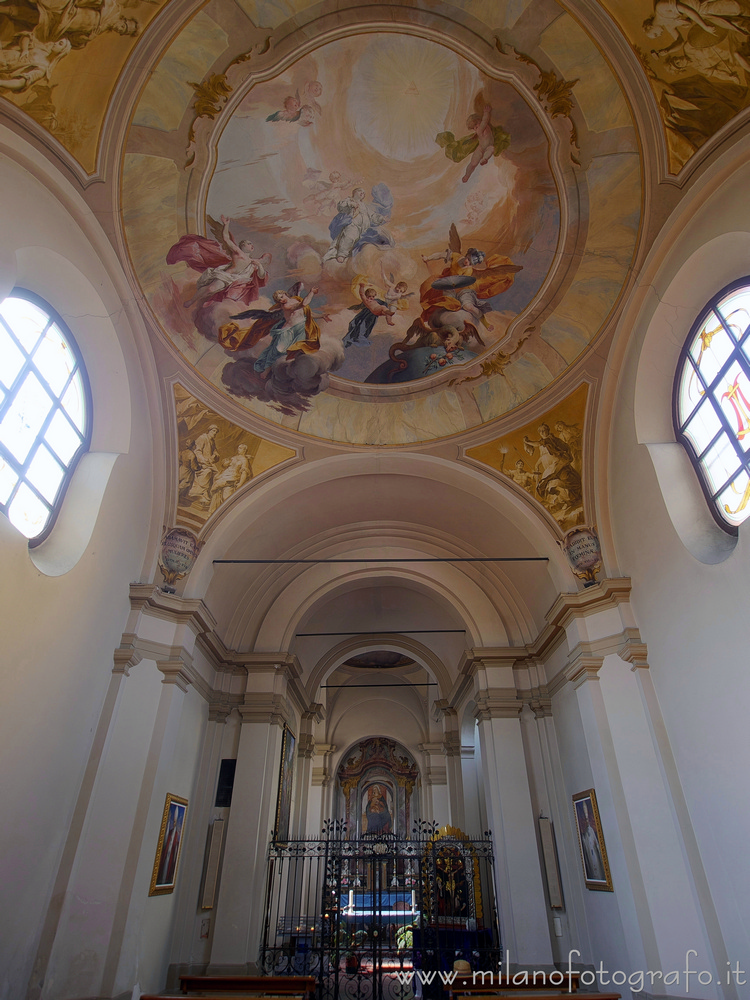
left=219, top=285, right=320, bottom=373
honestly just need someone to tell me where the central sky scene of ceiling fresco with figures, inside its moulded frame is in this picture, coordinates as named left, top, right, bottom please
left=165, top=35, right=560, bottom=413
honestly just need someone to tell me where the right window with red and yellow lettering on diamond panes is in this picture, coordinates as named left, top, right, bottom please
left=673, top=278, right=750, bottom=532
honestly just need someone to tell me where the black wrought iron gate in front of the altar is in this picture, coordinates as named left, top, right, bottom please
left=260, top=821, right=500, bottom=1000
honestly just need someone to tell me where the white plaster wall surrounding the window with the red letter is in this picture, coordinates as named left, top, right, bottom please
left=609, top=152, right=750, bottom=995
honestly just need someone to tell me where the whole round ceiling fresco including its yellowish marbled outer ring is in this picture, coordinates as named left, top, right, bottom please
left=122, top=4, right=641, bottom=445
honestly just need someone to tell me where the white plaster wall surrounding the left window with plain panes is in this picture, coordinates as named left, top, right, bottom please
left=0, top=133, right=159, bottom=1000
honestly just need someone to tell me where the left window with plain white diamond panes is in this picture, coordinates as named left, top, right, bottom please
left=0, top=288, right=91, bottom=545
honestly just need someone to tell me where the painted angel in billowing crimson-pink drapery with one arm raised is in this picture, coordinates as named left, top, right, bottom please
left=167, top=215, right=271, bottom=309
